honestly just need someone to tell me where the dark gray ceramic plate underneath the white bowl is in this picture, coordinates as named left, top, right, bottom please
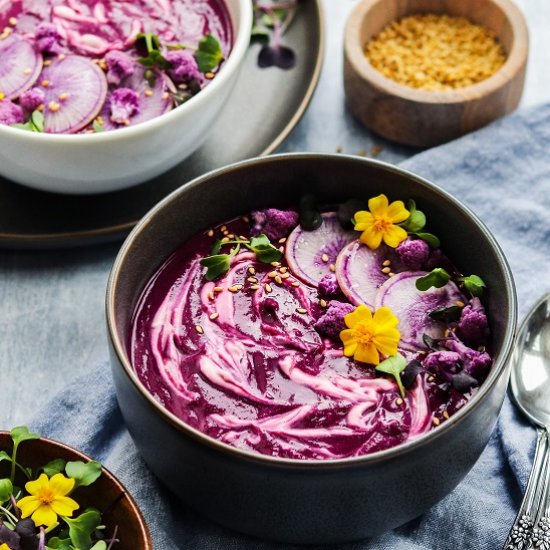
left=0, top=0, right=324, bottom=248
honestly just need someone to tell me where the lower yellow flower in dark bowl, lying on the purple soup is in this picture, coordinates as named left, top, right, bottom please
left=340, top=305, right=401, bottom=365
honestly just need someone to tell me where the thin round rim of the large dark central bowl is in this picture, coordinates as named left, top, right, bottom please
left=105, top=153, right=517, bottom=471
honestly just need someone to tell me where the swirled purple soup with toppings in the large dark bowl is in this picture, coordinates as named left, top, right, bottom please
left=128, top=198, right=492, bottom=459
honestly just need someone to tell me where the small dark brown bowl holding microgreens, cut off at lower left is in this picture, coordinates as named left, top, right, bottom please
left=0, top=432, right=153, bottom=550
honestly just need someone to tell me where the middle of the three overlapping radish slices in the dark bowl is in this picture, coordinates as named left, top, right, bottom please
left=336, top=240, right=403, bottom=309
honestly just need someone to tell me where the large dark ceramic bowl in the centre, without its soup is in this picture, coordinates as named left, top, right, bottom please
left=107, top=154, right=516, bottom=544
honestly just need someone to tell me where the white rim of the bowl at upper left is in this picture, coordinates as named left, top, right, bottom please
left=0, top=0, right=253, bottom=146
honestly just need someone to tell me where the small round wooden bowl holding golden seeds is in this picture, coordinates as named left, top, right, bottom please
left=344, top=0, right=529, bottom=147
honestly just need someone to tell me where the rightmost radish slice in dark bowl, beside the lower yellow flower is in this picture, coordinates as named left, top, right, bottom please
left=375, top=271, right=466, bottom=351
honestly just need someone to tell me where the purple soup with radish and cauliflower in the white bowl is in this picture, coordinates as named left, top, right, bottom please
left=0, top=0, right=233, bottom=133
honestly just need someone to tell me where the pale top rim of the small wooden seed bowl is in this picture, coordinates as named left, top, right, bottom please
left=344, top=0, right=529, bottom=105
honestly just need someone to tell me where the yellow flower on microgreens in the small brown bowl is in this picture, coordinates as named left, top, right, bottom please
left=17, top=474, right=79, bottom=527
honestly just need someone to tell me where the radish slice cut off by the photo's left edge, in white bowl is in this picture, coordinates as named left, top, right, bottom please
left=0, top=34, right=42, bottom=99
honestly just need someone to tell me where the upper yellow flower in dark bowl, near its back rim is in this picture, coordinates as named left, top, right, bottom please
left=355, top=195, right=410, bottom=250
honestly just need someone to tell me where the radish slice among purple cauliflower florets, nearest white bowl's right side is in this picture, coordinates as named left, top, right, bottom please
left=101, top=63, right=173, bottom=130
